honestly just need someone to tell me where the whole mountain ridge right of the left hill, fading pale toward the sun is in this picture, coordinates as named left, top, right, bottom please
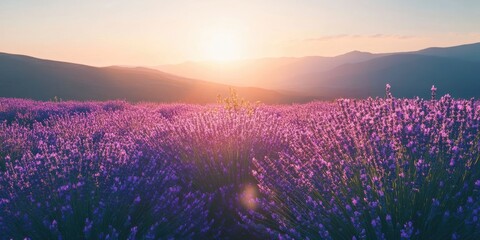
left=156, top=43, right=480, bottom=99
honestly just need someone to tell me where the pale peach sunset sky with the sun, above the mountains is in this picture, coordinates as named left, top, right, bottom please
left=0, top=0, right=480, bottom=66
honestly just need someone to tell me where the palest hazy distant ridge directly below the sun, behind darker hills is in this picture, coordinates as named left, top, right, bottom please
left=152, top=51, right=383, bottom=90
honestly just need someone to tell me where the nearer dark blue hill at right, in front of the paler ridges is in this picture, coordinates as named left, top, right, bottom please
left=298, top=54, right=480, bottom=99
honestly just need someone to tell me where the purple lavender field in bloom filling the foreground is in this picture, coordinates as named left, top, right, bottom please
left=0, top=95, right=480, bottom=239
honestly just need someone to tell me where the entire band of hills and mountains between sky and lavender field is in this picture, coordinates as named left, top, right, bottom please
left=0, top=43, right=480, bottom=103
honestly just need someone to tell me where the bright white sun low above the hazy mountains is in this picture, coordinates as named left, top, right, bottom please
left=204, top=30, right=242, bottom=61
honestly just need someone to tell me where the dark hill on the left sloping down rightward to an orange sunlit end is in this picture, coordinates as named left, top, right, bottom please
left=0, top=53, right=308, bottom=103
